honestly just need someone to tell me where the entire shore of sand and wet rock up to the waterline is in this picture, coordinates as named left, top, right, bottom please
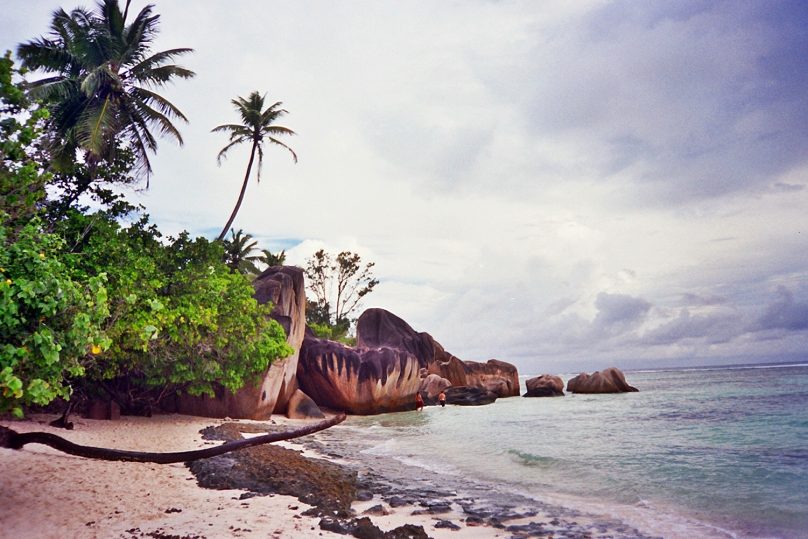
left=0, top=414, right=732, bottom=539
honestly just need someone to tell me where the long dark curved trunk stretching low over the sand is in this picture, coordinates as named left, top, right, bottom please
left=0, top=414, right=345, bottom=464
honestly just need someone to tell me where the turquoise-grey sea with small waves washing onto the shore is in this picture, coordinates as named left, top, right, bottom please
left=308, top=364, right=808, bottom=538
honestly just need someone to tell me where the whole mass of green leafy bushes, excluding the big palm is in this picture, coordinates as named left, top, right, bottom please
left=0, top=35, right=291, bottom=415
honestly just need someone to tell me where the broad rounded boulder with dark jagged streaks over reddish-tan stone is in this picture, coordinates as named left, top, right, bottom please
left=297, top=337, right=421, bottom=415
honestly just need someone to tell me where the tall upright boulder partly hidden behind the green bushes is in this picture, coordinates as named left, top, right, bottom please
left=177, top=266, right=306, bottom=419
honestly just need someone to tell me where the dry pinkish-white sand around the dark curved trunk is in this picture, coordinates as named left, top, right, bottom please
left=0, top=415, right=504, bottom=539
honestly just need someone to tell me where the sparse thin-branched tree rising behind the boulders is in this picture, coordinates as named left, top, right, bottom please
left=305, top=249, right=379, bottom=334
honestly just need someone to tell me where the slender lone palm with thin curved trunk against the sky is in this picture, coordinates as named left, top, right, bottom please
left=212, top=92, right=297, bottom=240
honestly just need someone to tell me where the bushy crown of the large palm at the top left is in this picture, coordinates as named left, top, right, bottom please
left=17, top=0, right=194, bottom=181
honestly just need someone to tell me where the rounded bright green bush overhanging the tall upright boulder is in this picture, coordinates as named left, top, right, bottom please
left=58, top=212, right=291, bottom=406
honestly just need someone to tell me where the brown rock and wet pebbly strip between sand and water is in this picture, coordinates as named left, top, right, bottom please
left=188, top=422, right=651, bottom=539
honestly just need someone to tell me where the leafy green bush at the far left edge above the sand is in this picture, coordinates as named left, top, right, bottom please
left=0, top=219, right=110, bottom=415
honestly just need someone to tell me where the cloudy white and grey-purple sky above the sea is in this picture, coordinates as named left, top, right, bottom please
left=0, top=0, right=808, bottom=374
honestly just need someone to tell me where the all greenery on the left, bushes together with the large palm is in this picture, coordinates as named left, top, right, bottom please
left=0, top=0, right=291, bottom=415
